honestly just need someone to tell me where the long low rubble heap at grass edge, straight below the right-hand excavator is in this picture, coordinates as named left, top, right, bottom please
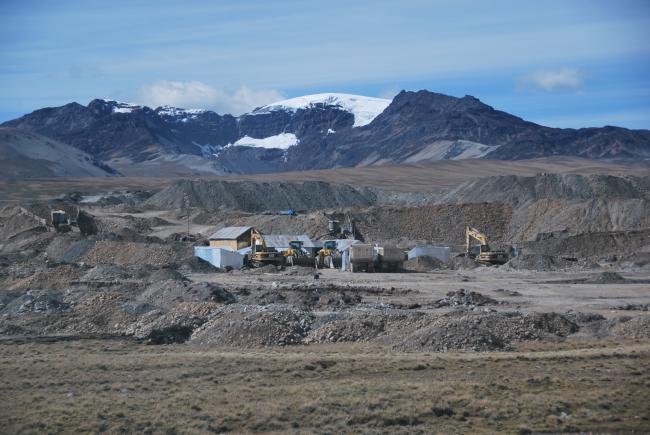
left=394, top=311, right=578, bottom=352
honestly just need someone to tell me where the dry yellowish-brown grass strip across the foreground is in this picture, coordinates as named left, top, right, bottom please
left=0, top=340, right=650, bottom=433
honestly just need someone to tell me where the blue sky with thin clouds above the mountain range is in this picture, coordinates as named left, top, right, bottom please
left=0, top=0, right=650, bottom=128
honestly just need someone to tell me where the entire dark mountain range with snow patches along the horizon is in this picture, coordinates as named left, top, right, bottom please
left=3, top=91, right=650, bottom=175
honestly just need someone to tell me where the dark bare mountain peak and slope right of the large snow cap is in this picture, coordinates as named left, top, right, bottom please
left=286, top=91, right=650, bottom=169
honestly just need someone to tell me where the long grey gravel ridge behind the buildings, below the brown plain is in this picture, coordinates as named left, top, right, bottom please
left=144, top=180, right=377, bottom=211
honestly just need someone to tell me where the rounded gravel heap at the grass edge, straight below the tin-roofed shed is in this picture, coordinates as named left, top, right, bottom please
left=190, top=305, right=313, bottom=346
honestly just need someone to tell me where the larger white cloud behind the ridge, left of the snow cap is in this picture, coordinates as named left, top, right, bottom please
left=138, top=80, right=284, bottom=115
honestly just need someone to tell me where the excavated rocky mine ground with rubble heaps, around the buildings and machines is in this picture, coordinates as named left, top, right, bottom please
left=0, top=170, right=650, bottom=351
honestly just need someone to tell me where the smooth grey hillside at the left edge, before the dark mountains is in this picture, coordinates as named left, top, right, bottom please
left=0, top=127, right=116, bottom=180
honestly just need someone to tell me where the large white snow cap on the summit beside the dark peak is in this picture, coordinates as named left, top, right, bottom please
left=251, top=93, right=391, bottom=127
